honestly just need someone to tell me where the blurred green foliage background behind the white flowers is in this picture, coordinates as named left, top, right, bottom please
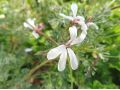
left=0, top=0, right=120, bottom=88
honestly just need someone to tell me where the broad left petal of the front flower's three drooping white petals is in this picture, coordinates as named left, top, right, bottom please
left=47, top=45, right=65, bottom=60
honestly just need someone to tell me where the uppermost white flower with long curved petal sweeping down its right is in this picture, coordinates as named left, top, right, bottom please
left=60, top=3, right=98, bottom=45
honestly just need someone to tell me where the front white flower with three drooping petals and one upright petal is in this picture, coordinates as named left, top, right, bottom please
left=47, top=26, right=78, bottom=71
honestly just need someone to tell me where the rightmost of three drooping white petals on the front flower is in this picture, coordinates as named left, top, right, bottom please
left=67, top=48, right=78, bottom=70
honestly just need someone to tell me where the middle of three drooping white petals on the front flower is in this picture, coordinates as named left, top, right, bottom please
left=58, top=48, right=67, bottom=71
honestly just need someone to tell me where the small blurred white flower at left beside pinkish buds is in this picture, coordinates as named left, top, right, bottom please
left=23, top=18, right=39, bottom=39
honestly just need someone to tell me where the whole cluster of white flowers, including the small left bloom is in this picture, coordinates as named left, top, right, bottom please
left=24, top=3, right=98, bottom=71
